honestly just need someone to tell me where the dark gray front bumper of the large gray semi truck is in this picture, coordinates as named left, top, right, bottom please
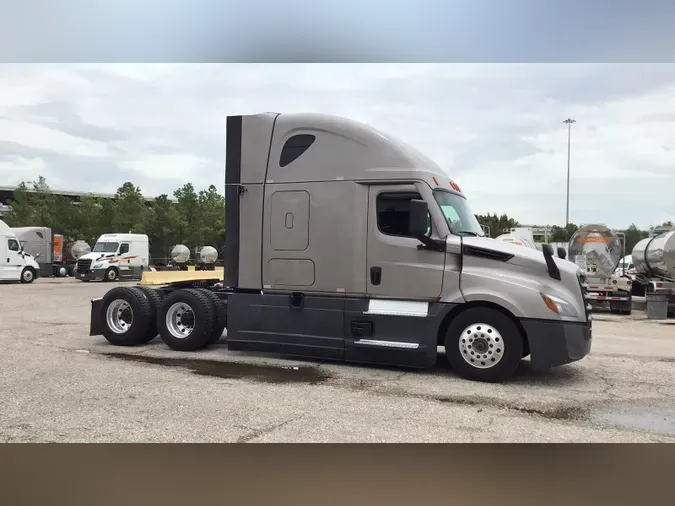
left=520, top=315, right=593, bottom=369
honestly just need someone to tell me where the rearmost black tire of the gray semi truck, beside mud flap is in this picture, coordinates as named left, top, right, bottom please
left=101, top=286, right=154, bottom=346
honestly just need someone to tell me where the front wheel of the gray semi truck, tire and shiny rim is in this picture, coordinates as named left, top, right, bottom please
left=444, top=307, right=524, bottom=383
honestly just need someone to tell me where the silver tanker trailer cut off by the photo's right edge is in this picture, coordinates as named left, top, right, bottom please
left=632, top=229, right=675, bottom=316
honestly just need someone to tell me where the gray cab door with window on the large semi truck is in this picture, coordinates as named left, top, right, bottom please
left=366, top=184, right=445, bottom=301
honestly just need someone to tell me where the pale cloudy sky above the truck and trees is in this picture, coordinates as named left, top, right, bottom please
left=0, top=63, right=675, bottom=228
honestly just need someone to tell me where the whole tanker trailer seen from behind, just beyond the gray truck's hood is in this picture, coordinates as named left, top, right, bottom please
left=568, top=224, right=633, bottom=315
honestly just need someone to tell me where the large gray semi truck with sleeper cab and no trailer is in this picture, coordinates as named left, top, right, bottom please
left=90, top=113, right=592, bottom=382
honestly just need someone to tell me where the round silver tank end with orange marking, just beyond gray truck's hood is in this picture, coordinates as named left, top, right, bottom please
left=568, top=225, right=623, bottom=278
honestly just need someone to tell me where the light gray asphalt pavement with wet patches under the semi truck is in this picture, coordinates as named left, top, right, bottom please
left=0, top=278, right=675, bottom=442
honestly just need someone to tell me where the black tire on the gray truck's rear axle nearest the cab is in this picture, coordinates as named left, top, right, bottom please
left=157, top=288, right=215, bottom=351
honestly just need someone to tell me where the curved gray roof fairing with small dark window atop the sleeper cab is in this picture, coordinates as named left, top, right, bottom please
left=234, top=113, right=452, bottom=190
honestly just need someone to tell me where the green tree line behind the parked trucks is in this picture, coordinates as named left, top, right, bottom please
left=5, top=177, right=673, bottom=260
